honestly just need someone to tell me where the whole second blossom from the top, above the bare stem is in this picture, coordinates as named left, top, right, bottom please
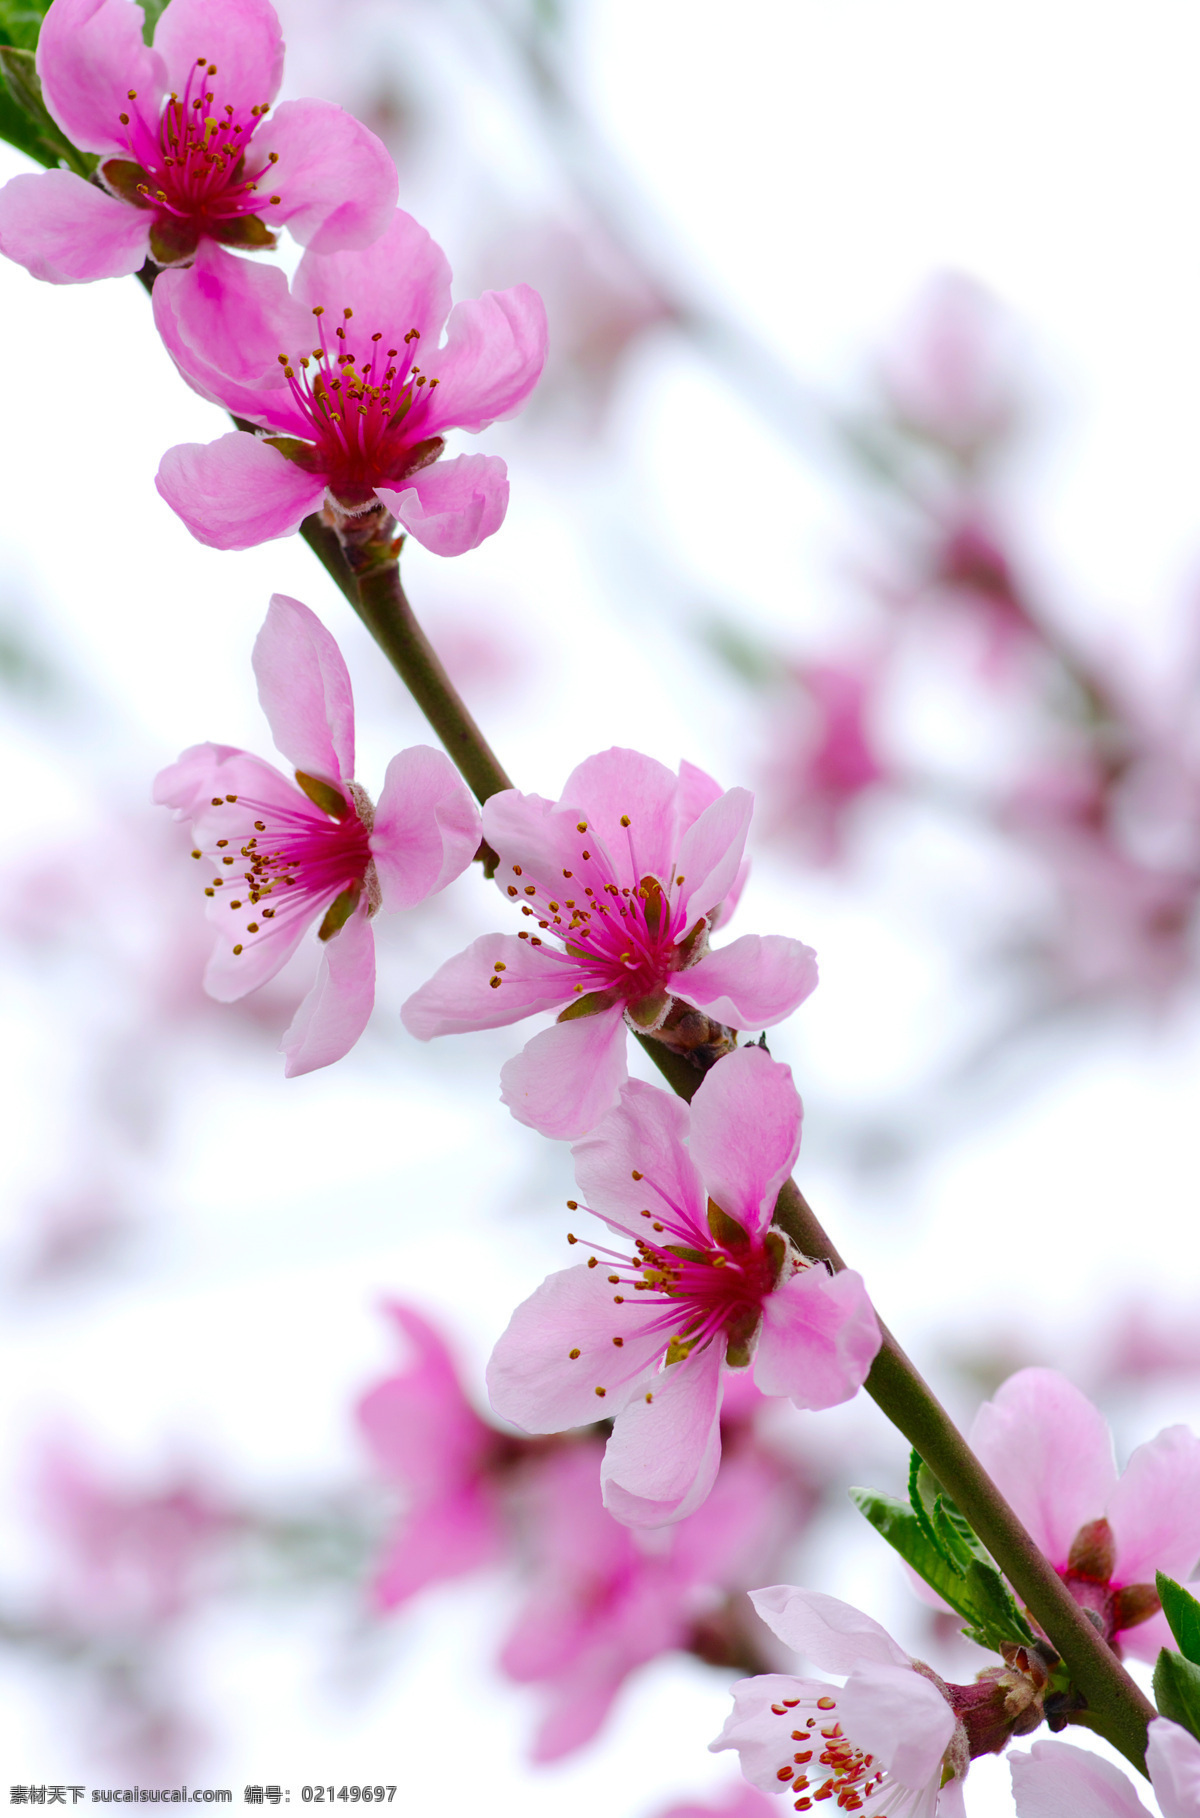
left=155, top=208, right=545, bottom=556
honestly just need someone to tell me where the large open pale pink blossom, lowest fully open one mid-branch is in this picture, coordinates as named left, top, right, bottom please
left=487, top=1047, right=880, bottom=1527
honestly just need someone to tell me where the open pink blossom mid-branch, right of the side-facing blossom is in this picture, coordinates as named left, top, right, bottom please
left=400, top=749, right=816, bottom=1138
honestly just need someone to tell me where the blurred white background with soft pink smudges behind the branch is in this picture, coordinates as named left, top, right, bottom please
left=0, top=0, right=1200, bottom=1818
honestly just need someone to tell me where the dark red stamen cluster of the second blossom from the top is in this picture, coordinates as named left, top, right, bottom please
left=273, top=304, right=445, bottom=513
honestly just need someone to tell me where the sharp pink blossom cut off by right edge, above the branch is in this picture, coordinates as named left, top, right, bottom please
left=971, top=1369, right=1200, bottom=1660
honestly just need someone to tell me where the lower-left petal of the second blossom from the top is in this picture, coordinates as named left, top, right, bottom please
left=155, top=430, right=325, bottom=549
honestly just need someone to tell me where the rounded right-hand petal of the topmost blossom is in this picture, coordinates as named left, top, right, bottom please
left=258, top=99, right=398, bottom=253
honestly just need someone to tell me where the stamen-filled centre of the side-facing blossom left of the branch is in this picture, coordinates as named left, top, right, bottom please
left=191, top=778, right=378, bottom=954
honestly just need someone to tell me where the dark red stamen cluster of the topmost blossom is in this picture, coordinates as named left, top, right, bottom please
left=104, top=56, right=280, bottom=262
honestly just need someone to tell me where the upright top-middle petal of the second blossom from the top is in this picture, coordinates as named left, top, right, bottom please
left=293, top=209, right=451, bottom=349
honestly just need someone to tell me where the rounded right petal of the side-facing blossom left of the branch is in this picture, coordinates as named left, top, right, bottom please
left=371, top=745, right=480, bottom=905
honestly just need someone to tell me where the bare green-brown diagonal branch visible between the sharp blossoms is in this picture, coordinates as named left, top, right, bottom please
left=302, top=538, right=1156, bottom=1773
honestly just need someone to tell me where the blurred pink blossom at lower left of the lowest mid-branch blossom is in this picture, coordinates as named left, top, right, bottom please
left=358, top=1302, right=513, bottom=1609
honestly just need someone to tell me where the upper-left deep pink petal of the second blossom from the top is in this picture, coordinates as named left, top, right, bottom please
left=153, top=249, right=313, bottom=440
